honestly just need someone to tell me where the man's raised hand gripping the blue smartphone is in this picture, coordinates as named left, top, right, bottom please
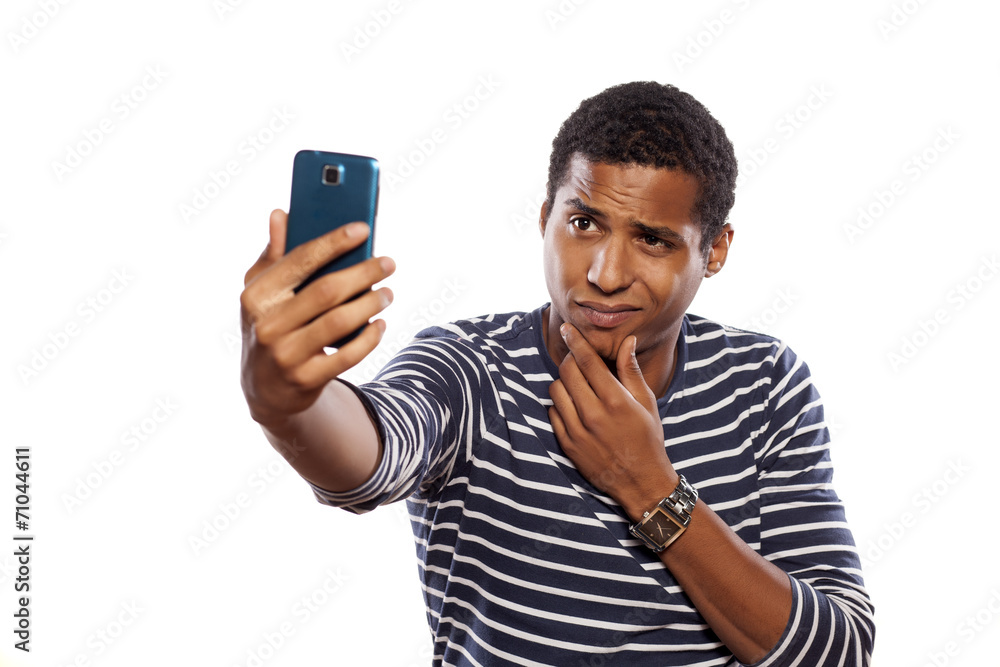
left=240, top=155, right=395, bottom=427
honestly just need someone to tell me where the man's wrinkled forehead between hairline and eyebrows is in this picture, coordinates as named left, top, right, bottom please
left=554, top=154, right=698, bottom=224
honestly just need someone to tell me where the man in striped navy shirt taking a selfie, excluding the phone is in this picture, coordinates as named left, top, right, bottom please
left=242, top=82, right=874, bottom=667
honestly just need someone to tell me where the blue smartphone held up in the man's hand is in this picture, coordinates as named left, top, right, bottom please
left=285, top=150, right=378, bottom=347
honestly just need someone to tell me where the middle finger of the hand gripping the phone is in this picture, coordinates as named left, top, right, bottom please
left=270, top=257, right=396, bottom=343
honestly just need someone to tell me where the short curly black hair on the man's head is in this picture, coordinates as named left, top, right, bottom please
left=545, top=81, right=737, bottom=252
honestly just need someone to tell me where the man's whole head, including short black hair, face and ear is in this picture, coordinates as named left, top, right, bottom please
left=540, top=83, right=736, bottom=392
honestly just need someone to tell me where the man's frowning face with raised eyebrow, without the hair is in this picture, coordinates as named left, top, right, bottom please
left=541, top=155, right=732, bottom=378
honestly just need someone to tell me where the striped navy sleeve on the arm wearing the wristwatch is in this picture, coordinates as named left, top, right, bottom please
left=755, top=345, right=875, bottom=667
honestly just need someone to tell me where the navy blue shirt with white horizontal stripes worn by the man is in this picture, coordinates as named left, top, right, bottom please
left=313, top=306, right=874, bottom=667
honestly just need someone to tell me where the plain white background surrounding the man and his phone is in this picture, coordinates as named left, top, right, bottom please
left=0, top=0, right=1000, bottom=666
